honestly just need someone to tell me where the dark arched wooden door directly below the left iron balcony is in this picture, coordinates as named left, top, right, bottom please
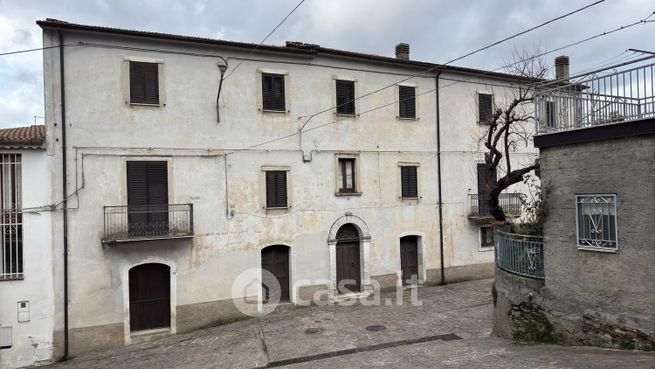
left=130, top=264, right=171, bottom=331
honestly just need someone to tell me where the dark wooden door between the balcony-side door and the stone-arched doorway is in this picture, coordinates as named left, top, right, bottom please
left=262, top=245, right=289, bottom=302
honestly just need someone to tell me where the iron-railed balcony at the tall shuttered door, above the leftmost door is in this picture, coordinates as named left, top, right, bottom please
left=102, top=204, right=193, bottom=244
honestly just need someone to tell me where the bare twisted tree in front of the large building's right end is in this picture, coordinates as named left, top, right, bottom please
left=482, top=50, right=548, bottom=222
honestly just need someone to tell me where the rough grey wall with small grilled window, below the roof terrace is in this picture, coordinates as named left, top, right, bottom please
left=541, top=135, right=655, bottom=349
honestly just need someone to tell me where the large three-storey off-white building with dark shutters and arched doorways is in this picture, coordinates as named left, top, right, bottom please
left=1, top=20, right=535, bottom=366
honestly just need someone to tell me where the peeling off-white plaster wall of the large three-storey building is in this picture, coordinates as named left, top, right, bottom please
left=39, top=27, right=540, bottom=352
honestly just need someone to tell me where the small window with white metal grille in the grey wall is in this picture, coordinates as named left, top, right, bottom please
left=575, top=194, right=619, bottom=251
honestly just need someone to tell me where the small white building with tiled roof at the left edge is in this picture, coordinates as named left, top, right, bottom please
left=0, top=126, right=55, bottom=368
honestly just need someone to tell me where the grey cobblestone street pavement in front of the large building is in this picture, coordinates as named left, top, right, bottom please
left=43, top=280, right=655, bottom=369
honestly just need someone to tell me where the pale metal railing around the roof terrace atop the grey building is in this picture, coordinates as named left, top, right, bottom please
left=535, top=64, right=655, bottom=134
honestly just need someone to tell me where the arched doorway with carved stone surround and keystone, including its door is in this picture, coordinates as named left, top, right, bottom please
left=328, top=213, right=371, bottom=294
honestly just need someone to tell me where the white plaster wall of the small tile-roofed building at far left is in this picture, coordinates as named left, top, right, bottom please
left=0, top=150, right=54, bottom=369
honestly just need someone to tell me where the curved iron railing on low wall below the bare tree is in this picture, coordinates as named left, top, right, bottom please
left=496, top=231, right=544, bottom=279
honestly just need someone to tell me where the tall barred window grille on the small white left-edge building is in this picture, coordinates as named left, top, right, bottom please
left=0, top=154, right=23, bottom=280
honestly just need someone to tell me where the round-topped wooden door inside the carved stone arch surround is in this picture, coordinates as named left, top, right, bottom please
left=336, top=224, right=362, bottom=293
